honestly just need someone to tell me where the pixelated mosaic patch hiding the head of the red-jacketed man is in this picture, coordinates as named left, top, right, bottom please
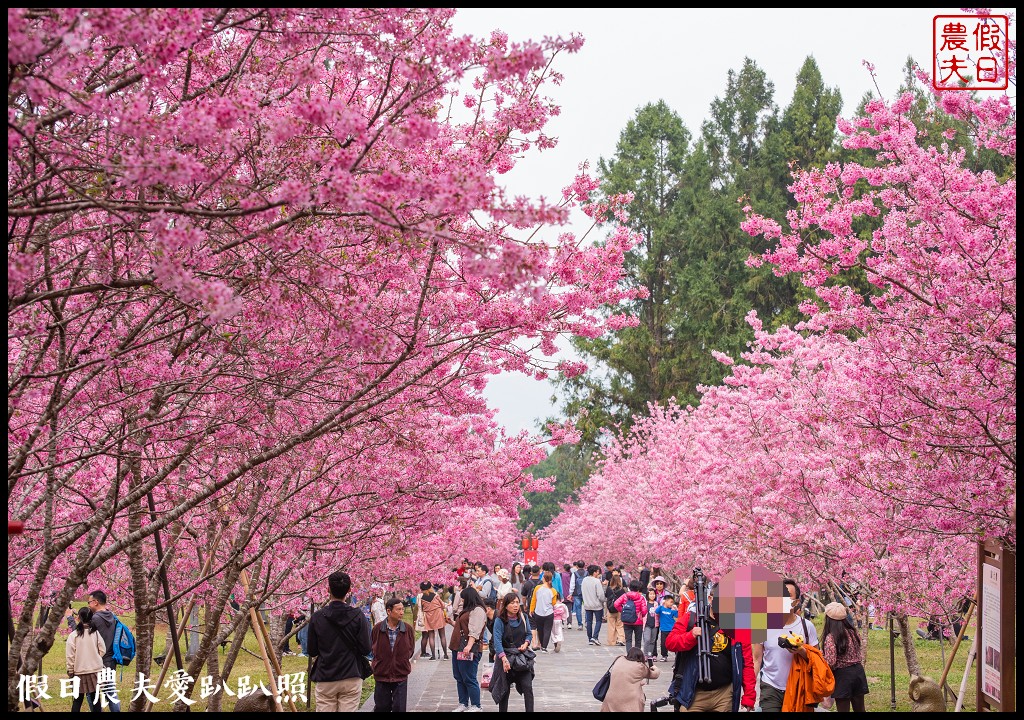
left=715, top=565, right=792, bottom=644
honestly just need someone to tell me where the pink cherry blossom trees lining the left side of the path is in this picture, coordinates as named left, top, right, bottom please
left=8, top=8, right=635, bottom=696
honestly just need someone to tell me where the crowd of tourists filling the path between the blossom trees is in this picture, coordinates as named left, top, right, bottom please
left=274, top=560, right=868, bottom=712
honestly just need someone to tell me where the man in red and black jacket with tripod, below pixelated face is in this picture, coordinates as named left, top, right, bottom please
left=665, top=586, right=757, bottom=713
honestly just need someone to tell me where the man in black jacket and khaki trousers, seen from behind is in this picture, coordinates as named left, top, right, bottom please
left=307, top=570, right=371, bottom=713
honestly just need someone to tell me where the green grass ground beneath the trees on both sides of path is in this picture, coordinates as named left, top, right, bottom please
left=18, top=606, right=976, bottom=712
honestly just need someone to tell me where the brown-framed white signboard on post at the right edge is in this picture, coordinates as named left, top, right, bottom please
left=977, top=541, right=1017, bottom=713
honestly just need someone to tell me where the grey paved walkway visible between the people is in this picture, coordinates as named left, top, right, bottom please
left=359, top=625, right=674, bottom=713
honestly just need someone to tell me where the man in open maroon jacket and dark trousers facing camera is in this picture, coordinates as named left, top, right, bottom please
left=370, top=597, right=416, bottom=713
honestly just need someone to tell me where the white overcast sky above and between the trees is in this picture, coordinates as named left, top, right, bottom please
left=454, top=8, right=1016, bottom=433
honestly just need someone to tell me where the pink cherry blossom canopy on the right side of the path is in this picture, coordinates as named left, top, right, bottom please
left=543, top=42, right=1017, bottom=617
